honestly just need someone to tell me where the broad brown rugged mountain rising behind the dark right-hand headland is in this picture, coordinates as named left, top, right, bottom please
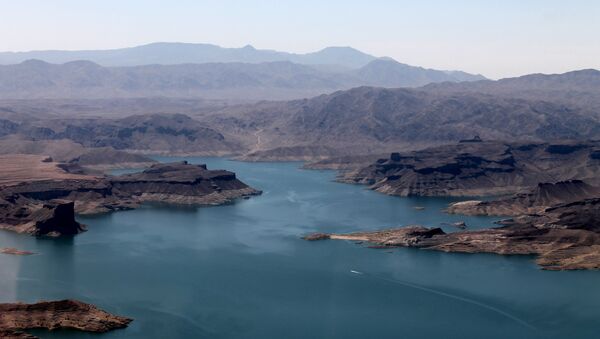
left=203, top=87, right=600, bottom=156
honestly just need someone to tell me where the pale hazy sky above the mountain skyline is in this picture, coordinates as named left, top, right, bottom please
left=0, top=0, right=600, bottom=78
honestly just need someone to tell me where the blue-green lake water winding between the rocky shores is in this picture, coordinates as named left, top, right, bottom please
left=0, top=158, right=600, bottom=338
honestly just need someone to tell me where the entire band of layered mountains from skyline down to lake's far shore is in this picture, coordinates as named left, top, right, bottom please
left=0, top=44, right=600, bottom=160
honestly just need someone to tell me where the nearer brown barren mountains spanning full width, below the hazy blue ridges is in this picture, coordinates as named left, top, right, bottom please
left=0, top=71, right=600, bottom=161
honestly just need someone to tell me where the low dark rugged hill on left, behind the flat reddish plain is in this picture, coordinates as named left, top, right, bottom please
left=9, top=114, right=244, bottom=157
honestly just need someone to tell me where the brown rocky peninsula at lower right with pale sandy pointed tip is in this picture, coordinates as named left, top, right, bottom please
left=308, top=198, right=600, bottom=270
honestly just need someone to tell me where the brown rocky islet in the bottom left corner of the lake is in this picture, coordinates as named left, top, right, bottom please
left=0, top=300, right=132, bottom=338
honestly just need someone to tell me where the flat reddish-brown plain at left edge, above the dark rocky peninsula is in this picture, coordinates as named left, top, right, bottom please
left=0, top=154, right=95, bottom=186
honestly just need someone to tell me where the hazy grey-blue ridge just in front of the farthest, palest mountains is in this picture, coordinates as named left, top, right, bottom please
left=0, top=60, right=481, bottom=100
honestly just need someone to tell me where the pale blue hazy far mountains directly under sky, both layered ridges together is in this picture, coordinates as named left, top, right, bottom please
left=0, top=43, right=484, bottom=100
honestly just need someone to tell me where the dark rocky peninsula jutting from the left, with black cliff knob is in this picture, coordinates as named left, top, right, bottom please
left=0, top=162, right=261, bottom=236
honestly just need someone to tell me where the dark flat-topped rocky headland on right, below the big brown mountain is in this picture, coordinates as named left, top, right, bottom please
left=339, top=141, right=600, bottom=196
